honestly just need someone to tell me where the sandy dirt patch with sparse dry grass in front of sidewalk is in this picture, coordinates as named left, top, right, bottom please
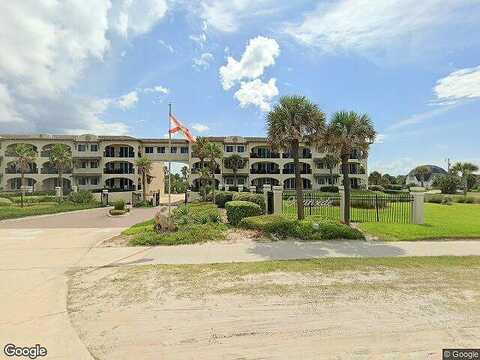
left=68, top=260, right=480, bottom=360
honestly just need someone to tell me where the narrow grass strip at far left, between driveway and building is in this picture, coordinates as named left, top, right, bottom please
left=0, top=202, right=99, bottom=220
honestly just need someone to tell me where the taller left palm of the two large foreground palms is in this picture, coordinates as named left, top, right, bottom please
left=266, top=96, right=325, bottom=220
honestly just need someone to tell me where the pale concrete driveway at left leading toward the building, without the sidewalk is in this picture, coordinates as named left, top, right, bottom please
left=0, top=208, right=161, bottom=360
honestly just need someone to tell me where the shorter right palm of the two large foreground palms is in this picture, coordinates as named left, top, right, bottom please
left=320, top=111, right=376, bottom=225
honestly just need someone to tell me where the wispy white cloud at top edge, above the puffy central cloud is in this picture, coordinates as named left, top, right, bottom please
left=200, top=0, right=278, bottom=32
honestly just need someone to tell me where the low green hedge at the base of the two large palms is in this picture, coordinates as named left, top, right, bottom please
left=239, top=215, right=364, bottom=240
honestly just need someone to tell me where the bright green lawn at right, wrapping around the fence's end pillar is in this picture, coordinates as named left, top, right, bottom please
left=359, top=204, right=480, bottom=240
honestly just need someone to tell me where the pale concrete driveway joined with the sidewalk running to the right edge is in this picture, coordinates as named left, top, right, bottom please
left=0, top=209, right=480, bottom=360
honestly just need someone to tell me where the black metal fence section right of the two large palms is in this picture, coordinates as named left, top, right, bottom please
left=350, top=193, right=413, bottom=224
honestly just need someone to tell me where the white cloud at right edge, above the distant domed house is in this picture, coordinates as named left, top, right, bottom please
left=434, top=66, right=480, bottom=104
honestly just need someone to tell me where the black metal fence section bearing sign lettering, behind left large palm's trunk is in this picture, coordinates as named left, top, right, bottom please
left=282, top=191, right=340, bottom=220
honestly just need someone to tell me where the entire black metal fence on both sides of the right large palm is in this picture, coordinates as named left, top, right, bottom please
left=282, top=191, right=413, bottom=224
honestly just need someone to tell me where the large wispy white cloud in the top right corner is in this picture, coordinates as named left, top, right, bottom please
left=286, top=0, right=479, bottom=56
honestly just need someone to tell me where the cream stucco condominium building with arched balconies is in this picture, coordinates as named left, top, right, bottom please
left=0, top=134, right=368, bottom=191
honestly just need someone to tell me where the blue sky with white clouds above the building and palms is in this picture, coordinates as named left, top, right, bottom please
left=0, top=0, right=480, bottom=175
